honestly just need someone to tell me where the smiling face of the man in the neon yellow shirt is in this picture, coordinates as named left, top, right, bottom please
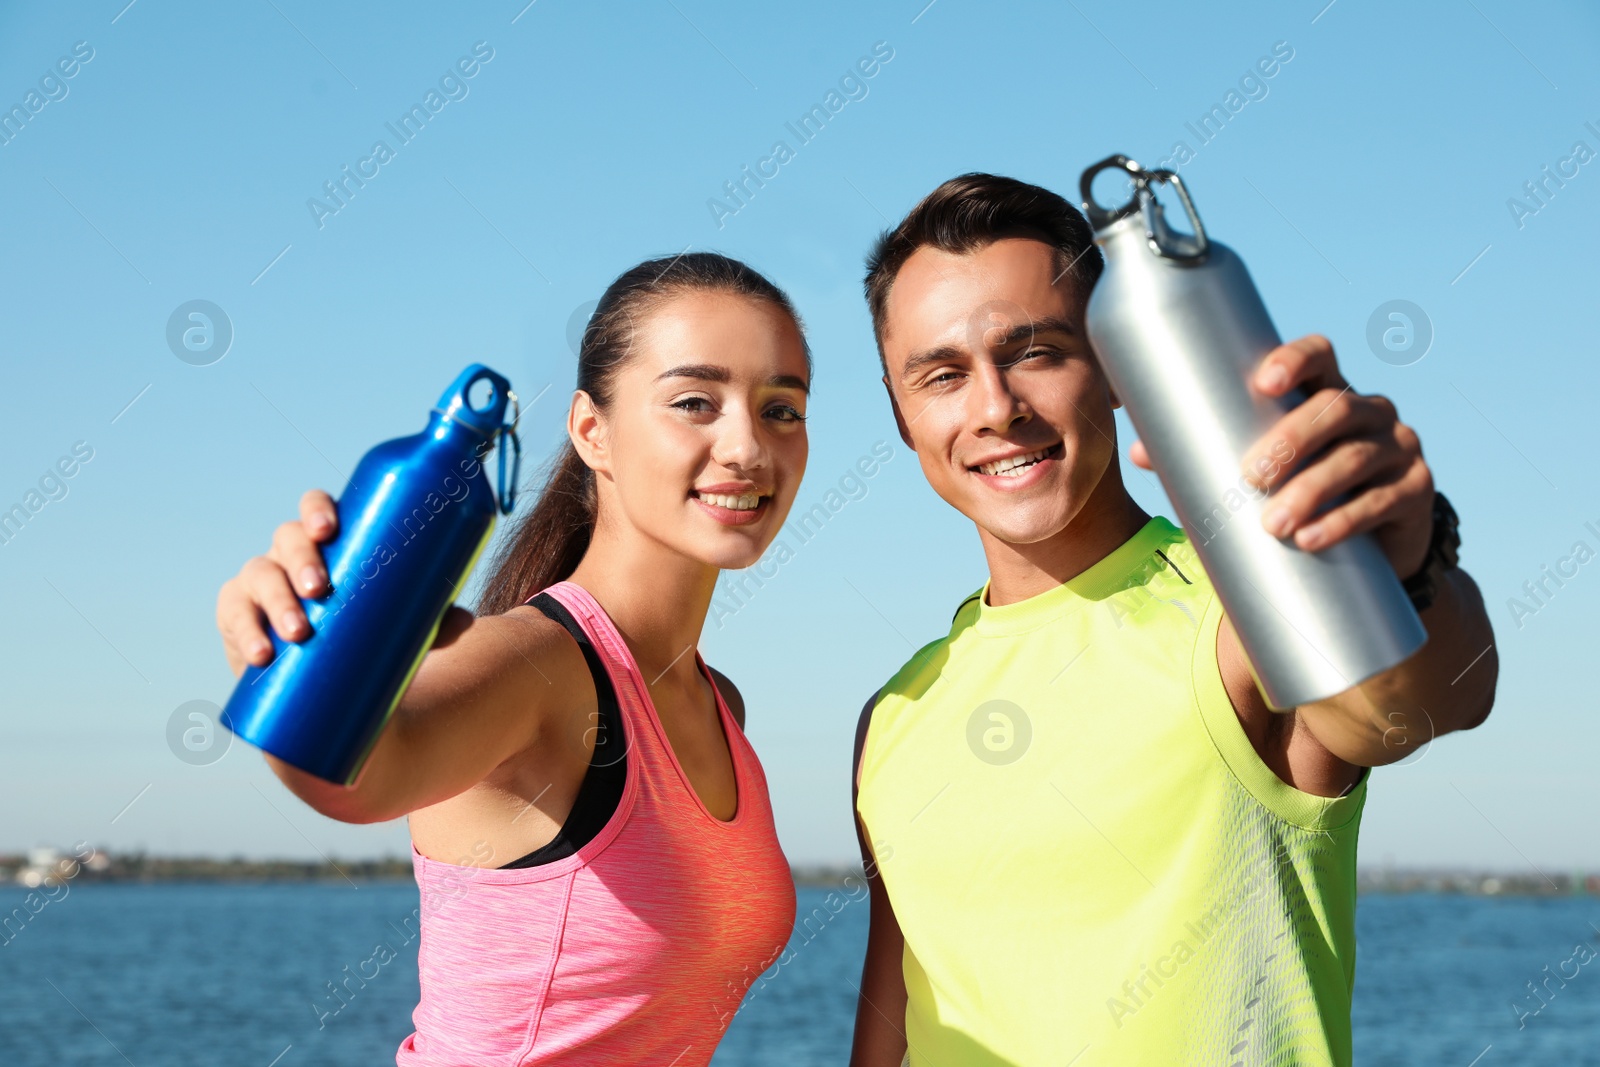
left=882, top=237, right=1117, bottom=545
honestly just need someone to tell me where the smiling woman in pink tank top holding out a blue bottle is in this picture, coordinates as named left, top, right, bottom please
left=218, top=253, right=811, bottom=1067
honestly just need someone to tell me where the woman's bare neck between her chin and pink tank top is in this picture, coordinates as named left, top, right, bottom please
left=568, top=525, right=722, bottom=685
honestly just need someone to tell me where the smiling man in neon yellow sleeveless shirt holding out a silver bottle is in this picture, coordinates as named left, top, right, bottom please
left=851, top=174, right=1496, bottom=1067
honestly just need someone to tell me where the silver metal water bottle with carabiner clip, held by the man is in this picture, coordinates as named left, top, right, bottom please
left=1080, top=155, right=1427, bottom=710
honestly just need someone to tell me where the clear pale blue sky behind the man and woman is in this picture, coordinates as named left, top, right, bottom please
left=0, top=0, right=1600, bottom=869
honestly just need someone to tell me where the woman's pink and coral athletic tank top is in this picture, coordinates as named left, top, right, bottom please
left=395, top=582, right=795, bottom=1067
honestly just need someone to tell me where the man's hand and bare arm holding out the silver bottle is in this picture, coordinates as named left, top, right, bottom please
left=1128, top=334, right=1499, bottom=767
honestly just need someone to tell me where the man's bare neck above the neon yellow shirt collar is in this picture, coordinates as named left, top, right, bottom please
left=978, top=476, right=1150, bottom=608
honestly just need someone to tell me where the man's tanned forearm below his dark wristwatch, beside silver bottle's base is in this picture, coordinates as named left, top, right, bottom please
left=1298, top=568, right=1499, bottom=766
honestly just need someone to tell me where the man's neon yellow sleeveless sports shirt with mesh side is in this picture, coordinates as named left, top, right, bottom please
left=858, top=517, right=1366, bottom=1067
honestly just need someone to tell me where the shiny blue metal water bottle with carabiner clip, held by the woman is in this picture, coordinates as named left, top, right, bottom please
left=222, top=363, right=522, bottom=785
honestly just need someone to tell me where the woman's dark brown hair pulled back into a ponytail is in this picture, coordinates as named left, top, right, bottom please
left=477, top=253, right=811, bottom=616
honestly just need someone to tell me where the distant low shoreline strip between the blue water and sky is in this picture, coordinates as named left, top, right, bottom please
left=0, top=849, right=1600, bottom=897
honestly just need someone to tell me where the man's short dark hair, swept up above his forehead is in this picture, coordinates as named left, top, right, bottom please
left=866, top=173, right=1104, bottom=362
